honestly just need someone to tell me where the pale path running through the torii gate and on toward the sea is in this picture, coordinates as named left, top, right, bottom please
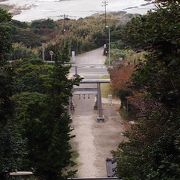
left=72, top=48, right=124, bottom=177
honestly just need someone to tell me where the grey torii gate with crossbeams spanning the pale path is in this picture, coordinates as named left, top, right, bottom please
left=73, top=79, right=110, bottom=122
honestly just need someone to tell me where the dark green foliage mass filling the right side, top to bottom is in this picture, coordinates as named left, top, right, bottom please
left=115, top=1, right=180, bottom=180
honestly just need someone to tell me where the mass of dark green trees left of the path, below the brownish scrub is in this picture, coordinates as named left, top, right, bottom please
left=0, top=9, right=79, bottom=180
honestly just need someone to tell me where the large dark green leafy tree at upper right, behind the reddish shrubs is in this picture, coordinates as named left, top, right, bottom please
left=122, top=1, right=180, bottom=106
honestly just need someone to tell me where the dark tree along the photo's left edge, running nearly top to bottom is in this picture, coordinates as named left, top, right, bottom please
left=0, top=9, right=23, bottom=179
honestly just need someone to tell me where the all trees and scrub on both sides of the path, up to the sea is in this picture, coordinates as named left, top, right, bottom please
left=0, top=0, right=180, bottom=180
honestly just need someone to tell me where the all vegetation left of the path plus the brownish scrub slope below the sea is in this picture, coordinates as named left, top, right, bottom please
left=0, top=9, right=134, bottom=180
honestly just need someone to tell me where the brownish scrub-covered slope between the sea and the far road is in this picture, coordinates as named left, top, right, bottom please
left=8, top=12, right=133, bottom=60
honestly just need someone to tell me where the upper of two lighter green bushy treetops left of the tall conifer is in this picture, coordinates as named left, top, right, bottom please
left=13, top=58, right=52, bottom=94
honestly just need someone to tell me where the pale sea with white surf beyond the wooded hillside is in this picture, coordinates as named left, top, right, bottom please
left=0, top=0, right=153, bottom=21
